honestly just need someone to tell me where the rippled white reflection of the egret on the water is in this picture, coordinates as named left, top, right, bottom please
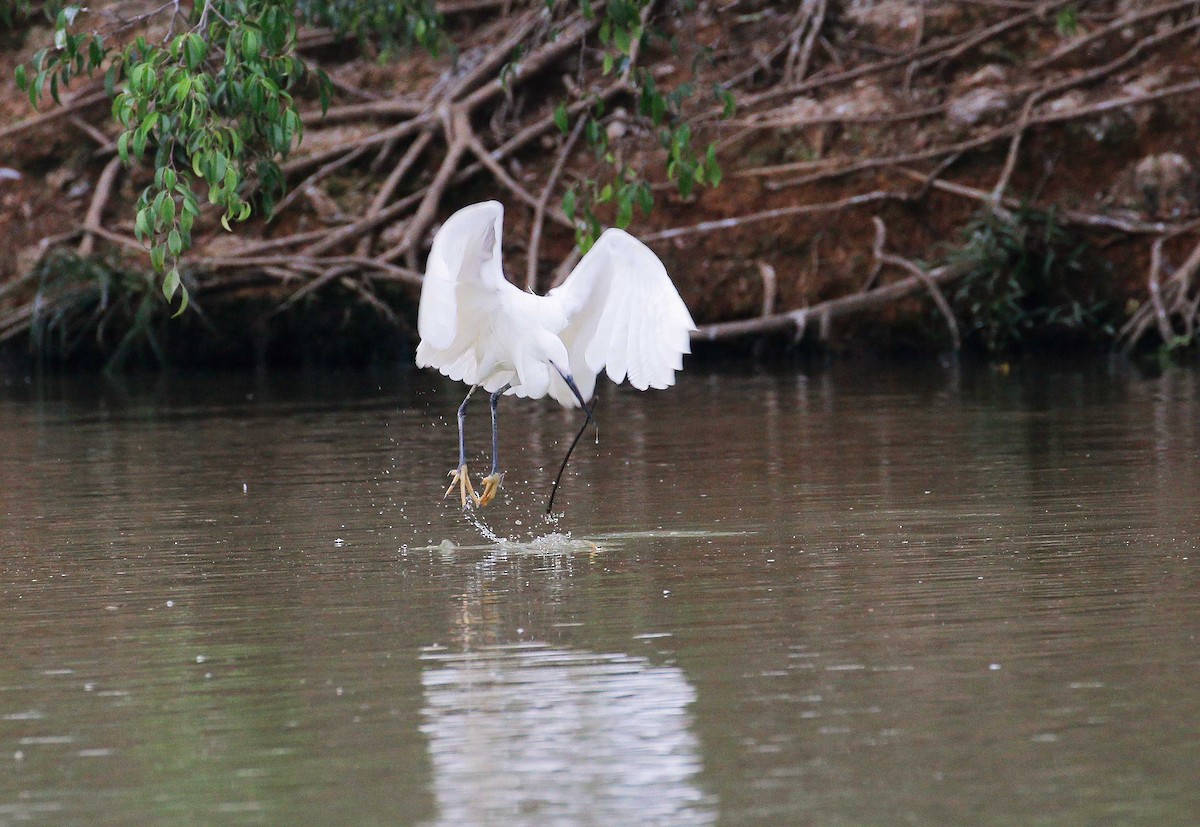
left=421, top=643, right=715, bottom=825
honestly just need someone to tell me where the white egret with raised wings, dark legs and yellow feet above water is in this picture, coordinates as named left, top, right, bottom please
left=416, top=200, right=696, bottom=510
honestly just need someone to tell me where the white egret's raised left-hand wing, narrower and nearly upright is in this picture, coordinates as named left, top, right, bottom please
left=416, top=200, right=515, bottom=390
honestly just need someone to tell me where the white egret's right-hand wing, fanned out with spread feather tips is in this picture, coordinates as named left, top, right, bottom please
left=548, top=229, right=696, bottom=407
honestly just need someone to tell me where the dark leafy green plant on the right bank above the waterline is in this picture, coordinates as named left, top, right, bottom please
left=949, top=209, right=1114, bottom=358
